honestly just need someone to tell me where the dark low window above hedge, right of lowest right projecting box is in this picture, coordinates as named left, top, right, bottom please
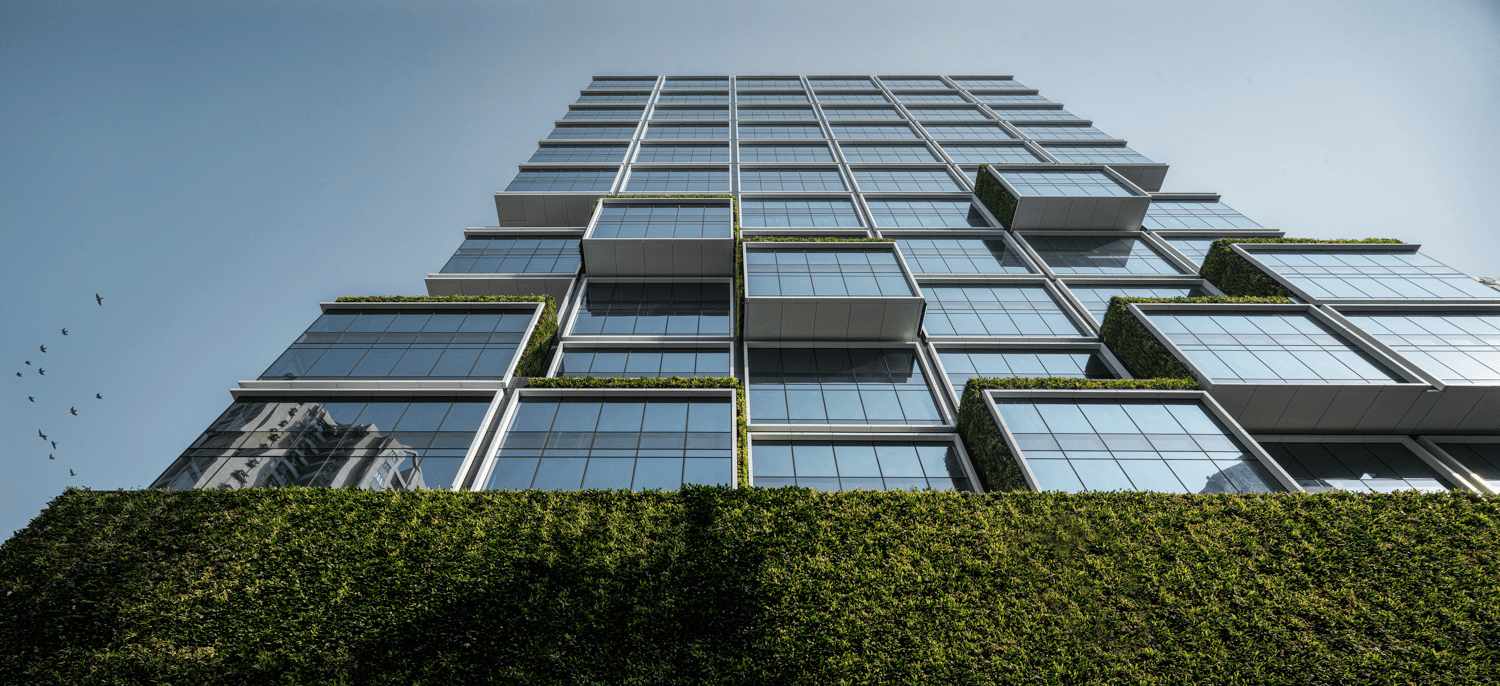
left=1260, top=441, right=1454, bottom=492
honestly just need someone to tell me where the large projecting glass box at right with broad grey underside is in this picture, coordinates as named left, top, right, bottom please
left=1116, top=303, right=1439, bottom=434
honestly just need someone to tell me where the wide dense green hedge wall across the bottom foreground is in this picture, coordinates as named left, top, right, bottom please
left=0, top=488, right=1500, bottom=684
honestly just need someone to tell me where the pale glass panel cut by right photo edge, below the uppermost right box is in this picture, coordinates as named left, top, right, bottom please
left=1346, top=312, right=1500, bottom=384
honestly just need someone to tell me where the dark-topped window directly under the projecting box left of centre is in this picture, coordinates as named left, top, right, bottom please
left=572, top=282, right=734, bottom=336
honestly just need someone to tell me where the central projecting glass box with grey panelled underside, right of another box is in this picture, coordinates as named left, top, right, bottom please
left=743, top=242, right=927, bottom=342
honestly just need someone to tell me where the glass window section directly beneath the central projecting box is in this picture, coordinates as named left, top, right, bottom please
left=747, top=348, right=944, bottom=425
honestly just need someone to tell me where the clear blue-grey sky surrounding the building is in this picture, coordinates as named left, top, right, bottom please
left=0, top=0, right=1500, bottom=537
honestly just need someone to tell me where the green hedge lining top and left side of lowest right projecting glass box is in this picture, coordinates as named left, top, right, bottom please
left=959, top=377, right=1199, bottom=492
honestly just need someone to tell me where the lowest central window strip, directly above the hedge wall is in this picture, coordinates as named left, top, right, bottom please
left=752, top=440, right=971, bottom=491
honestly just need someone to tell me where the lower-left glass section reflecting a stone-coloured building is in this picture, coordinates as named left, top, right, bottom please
left=152, top=396, right=491, bottom=491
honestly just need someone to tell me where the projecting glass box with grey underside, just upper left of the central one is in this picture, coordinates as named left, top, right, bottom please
left=584, top=198, right=735, bottom=278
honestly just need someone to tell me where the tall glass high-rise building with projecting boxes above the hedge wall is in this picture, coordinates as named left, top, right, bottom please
left=156, top=75, right=1500, bottom=492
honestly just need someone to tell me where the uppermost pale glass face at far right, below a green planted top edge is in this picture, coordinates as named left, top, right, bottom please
left=1256, top=251, right=1497, bottom=300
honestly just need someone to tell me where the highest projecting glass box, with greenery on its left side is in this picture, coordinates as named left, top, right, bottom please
left=975, top=165, right=1151, bottom=231
